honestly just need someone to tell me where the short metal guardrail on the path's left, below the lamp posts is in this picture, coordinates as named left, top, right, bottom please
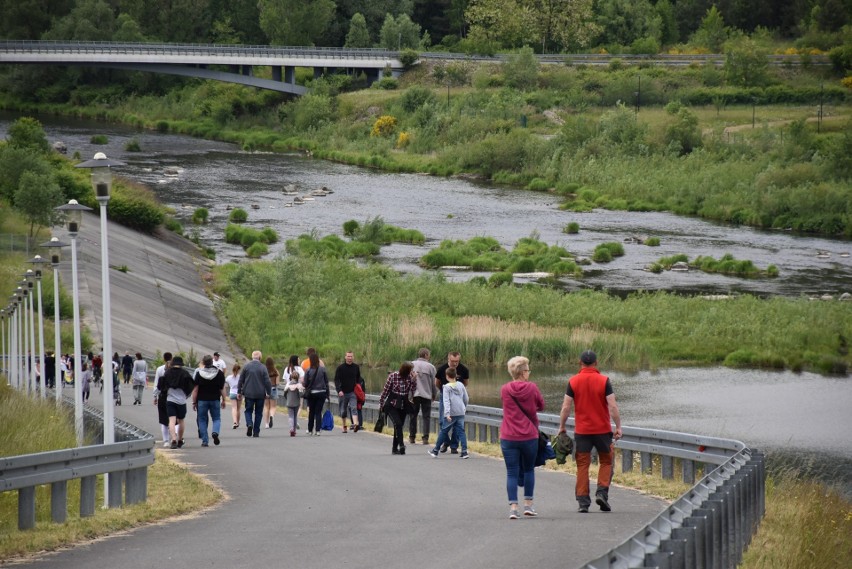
left=0, top=399, right=154, bottom=530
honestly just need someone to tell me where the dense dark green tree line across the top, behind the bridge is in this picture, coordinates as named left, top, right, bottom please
left=0, top=0, right=852, bottom=51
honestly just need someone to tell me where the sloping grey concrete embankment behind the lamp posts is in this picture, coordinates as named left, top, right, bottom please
left=57, top=213, right=242, bottom=365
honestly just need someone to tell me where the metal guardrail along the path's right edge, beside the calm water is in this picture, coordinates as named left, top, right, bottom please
left=346, top=394, right=766, bottom=569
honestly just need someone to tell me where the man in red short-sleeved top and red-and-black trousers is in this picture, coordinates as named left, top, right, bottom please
left=559, top=350, right=621, bottom=514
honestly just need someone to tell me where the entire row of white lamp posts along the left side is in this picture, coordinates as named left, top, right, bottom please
left=0, top=152, right=124, bottom=506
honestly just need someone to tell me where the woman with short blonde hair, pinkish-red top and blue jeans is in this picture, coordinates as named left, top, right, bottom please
left=500, top=356, right=544, bottom=520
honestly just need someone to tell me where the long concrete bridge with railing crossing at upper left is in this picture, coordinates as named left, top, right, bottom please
left=0, top=40, right=403, bottom=95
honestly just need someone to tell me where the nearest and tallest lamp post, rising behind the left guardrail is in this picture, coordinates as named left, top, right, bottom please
left=76, top=152, right=125, bottom=508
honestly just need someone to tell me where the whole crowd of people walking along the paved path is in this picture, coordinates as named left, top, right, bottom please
left=40, top=342, right=622, bottom=519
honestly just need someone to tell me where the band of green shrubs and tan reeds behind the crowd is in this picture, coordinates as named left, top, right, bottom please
left=216, top=256, right=852, bottom=371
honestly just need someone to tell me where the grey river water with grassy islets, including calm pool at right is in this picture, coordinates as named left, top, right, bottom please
left=5, top=115, right=852, bottom=496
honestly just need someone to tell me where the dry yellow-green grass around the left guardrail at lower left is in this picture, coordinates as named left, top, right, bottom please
left=0, top=378, right=223, bottom=561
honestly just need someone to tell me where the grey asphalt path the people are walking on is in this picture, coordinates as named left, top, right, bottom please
left=18, top=392, right=665, bottom=569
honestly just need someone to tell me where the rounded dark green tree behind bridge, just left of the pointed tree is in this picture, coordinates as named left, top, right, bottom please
left=258, top=0, right=335, bottom=45
